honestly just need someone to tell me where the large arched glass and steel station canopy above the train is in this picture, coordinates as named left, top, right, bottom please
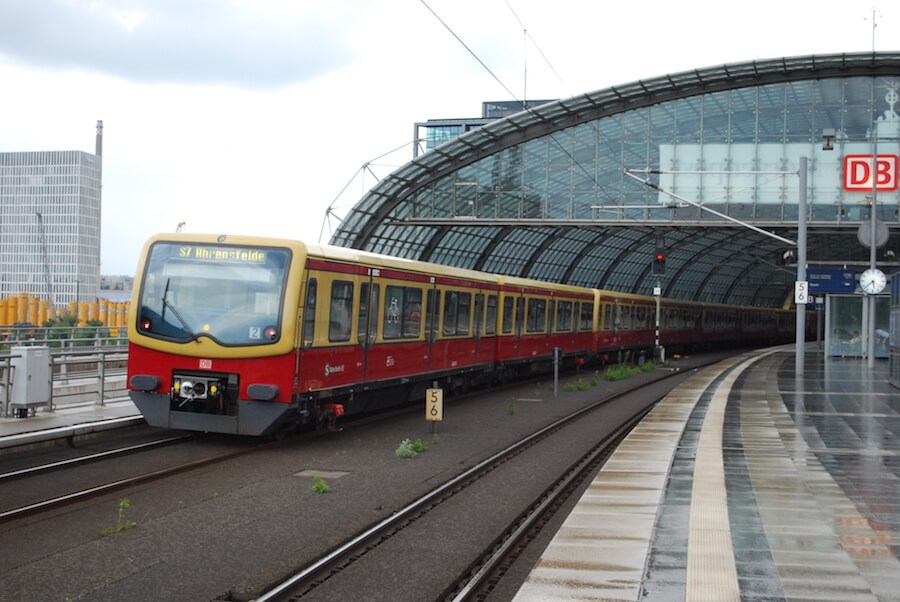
left=331, top=53, right=900, bottom=307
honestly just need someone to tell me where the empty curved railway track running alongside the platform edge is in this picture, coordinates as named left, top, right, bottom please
left=250, top=360, right=700, bottom=602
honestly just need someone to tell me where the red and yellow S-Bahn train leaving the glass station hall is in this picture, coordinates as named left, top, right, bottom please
left=128, top=234, right=794, bottom=435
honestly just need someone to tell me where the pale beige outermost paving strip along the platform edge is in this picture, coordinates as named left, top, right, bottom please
left=514, top=358, right=742, bottom=602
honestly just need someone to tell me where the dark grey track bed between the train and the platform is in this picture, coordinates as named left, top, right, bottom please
left=0, top=350, right=740, bottom=602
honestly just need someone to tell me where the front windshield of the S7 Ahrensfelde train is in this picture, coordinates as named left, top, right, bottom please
left=137, top=242, right=291, bottom=345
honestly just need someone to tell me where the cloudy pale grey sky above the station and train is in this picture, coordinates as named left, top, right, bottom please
left=0, top=0, right=900, bottom=274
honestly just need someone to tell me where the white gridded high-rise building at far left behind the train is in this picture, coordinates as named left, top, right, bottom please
left=0, top=151, right=101, bottom=304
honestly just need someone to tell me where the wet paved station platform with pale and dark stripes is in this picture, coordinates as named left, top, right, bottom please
left=515, top=351, right=900, bottom=602
